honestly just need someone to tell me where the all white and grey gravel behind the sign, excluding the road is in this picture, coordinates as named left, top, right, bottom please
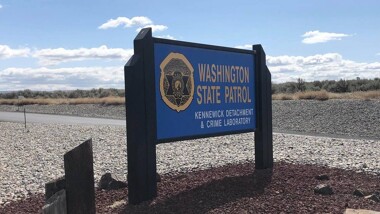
left=0, top=100, right=380, bottom=212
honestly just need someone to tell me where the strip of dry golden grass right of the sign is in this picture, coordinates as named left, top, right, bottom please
left=272, top=90, right=380, bottom=100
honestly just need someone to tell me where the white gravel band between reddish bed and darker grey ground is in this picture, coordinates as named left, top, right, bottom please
left=0, top=122, right=380, bottom=206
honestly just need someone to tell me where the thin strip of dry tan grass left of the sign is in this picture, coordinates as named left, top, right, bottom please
left=0, top=97, right=125, bottom=105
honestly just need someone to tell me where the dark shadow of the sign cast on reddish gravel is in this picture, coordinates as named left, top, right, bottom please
left=123, top=169, right=273, bottom=213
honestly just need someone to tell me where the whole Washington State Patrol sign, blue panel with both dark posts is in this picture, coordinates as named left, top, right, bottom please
left=124, top=28, right=273, bottom=204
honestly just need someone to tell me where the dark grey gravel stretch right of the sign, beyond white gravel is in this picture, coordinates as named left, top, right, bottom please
left=273, top=100, right=380, bottom=139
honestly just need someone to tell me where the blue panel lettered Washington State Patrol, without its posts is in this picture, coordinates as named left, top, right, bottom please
left=154, top=43, right=256, bottom=140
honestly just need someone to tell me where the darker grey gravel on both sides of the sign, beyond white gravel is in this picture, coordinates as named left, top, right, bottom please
left=0, top=100, right=380, bottom=139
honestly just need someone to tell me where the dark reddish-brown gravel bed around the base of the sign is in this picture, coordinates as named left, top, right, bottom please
left=0, top=163, right=380, bottom=213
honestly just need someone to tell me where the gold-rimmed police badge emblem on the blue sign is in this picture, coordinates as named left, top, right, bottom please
left=160, top=53, right=194, bottom=112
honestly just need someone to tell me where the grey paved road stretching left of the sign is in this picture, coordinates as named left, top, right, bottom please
left=0, top=112, right=126, bottom=126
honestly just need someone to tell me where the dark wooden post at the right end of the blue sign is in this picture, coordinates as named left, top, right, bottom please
left=252, top=45, right=273, bottom=169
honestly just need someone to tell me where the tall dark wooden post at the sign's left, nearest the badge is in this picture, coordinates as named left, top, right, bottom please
left=124, top=28, right=157, bottom=204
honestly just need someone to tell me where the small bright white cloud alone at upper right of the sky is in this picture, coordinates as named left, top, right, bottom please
left=302, top=30, right=350, bottom=44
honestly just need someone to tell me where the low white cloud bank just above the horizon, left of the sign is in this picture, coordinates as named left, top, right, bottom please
left=0, top=66, right=124, bottom=91
